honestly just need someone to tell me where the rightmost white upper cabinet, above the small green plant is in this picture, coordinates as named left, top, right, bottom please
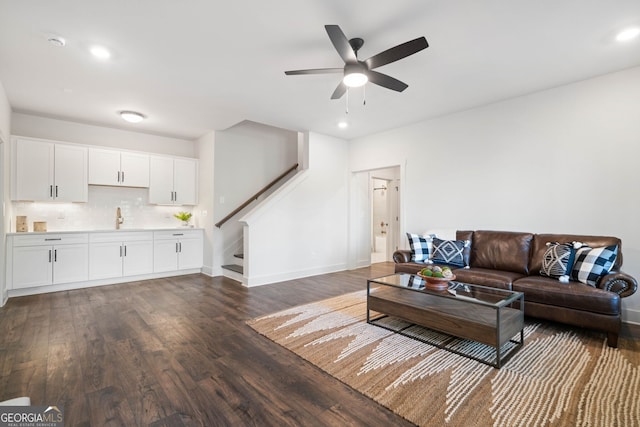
left=149, top=156, right=198, bottom=205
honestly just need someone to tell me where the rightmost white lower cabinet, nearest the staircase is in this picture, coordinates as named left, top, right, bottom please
left=153, top=230, right=203, bottom=273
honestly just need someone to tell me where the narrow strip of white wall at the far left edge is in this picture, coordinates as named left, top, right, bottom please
left=0, top=82, right=11, bottom=307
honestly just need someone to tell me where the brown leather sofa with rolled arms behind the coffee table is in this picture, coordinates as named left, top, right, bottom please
left=393, top=230, right=638, bottom=347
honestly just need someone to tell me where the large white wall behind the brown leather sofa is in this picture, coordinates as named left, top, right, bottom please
left=349, top=68, right=640, bottom=323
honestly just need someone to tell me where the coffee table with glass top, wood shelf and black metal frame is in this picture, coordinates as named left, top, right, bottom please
left=367, top=273, right=524, bottom=368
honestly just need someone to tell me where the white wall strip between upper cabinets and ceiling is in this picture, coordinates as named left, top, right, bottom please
left=11, top=114, right=196, bottom=157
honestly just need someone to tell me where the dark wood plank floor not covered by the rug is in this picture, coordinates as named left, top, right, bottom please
left=0, top=263, right=420, bottom=426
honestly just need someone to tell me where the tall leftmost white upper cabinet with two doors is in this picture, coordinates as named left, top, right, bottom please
left=12, top=138, right=88, bottom=202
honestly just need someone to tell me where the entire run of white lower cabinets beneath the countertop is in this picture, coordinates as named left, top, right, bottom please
left=5, top=229, right=203, bottom=296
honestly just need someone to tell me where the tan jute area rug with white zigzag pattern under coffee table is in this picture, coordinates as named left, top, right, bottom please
left=248, top=291, right=640, bottom=427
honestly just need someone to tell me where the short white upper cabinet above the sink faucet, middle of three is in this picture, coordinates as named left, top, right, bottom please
left=89, top=148, right=149, bottom=187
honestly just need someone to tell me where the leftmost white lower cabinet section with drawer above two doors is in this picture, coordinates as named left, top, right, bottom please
left=11, top=233, right=88, bottom=289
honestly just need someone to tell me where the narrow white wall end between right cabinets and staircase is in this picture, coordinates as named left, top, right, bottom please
left=196, top=131, right=216, bottom=276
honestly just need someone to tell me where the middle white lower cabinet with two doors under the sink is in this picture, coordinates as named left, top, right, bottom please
left=89, top=231, right=153, bottom=280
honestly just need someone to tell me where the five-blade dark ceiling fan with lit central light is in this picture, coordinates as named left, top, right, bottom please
left=284, top=25, right=429, bottom=99
